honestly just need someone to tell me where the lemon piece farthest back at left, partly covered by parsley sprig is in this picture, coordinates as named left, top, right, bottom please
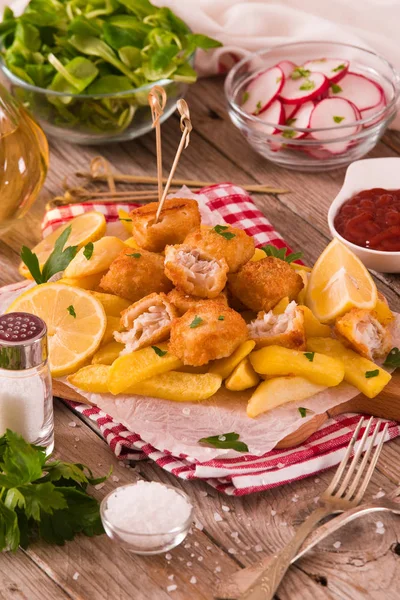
left=18, top=212, right=106, bottom=279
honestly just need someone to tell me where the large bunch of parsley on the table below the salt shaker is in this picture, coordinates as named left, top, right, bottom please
left=0, top=429, right=107, bottom=552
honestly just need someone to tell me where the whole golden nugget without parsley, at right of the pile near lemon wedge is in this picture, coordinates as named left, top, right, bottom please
left=228, top=256, right=304, bottom=312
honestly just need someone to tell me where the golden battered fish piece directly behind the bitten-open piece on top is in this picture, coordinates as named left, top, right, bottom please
left=185, top=225, right=254, bottom=273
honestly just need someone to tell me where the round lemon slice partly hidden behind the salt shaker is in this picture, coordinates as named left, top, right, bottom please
left=7, top=283, right=107, bottom=377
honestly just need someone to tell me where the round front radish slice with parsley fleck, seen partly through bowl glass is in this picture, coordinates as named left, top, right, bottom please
left=310, top=98, right=360, bottom=154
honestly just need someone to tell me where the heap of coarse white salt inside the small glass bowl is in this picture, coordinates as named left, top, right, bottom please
left=102, top=480, right=192, bottom=544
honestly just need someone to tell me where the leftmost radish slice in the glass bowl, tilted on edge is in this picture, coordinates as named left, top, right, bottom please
left=241, top=67, right=285, bottom=115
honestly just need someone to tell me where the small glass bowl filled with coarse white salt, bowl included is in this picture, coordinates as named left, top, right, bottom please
left=100, top=480, right=193, bottom=554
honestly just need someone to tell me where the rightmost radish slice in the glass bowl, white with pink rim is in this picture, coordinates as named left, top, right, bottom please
left=329, top=73, right=384, bottom=111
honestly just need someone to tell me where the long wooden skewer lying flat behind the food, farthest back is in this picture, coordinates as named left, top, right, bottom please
left=75, top=171, right=290, bottom=194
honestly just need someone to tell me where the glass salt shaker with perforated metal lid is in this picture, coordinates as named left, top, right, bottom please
left=0, top=312, right=54, bottom=454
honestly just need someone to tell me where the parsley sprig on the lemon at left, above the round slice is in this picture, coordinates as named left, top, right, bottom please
left=21, top=225, right=78, bottom=284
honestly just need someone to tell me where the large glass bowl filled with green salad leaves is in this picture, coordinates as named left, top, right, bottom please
left=0, top=0, right=221, bottom=144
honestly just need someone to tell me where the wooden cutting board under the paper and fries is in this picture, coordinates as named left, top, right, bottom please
left=53, top=370, right=400, bottom=448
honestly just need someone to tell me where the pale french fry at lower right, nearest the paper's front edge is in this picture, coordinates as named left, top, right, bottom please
left=247, top=377, right=326, bottom=418
